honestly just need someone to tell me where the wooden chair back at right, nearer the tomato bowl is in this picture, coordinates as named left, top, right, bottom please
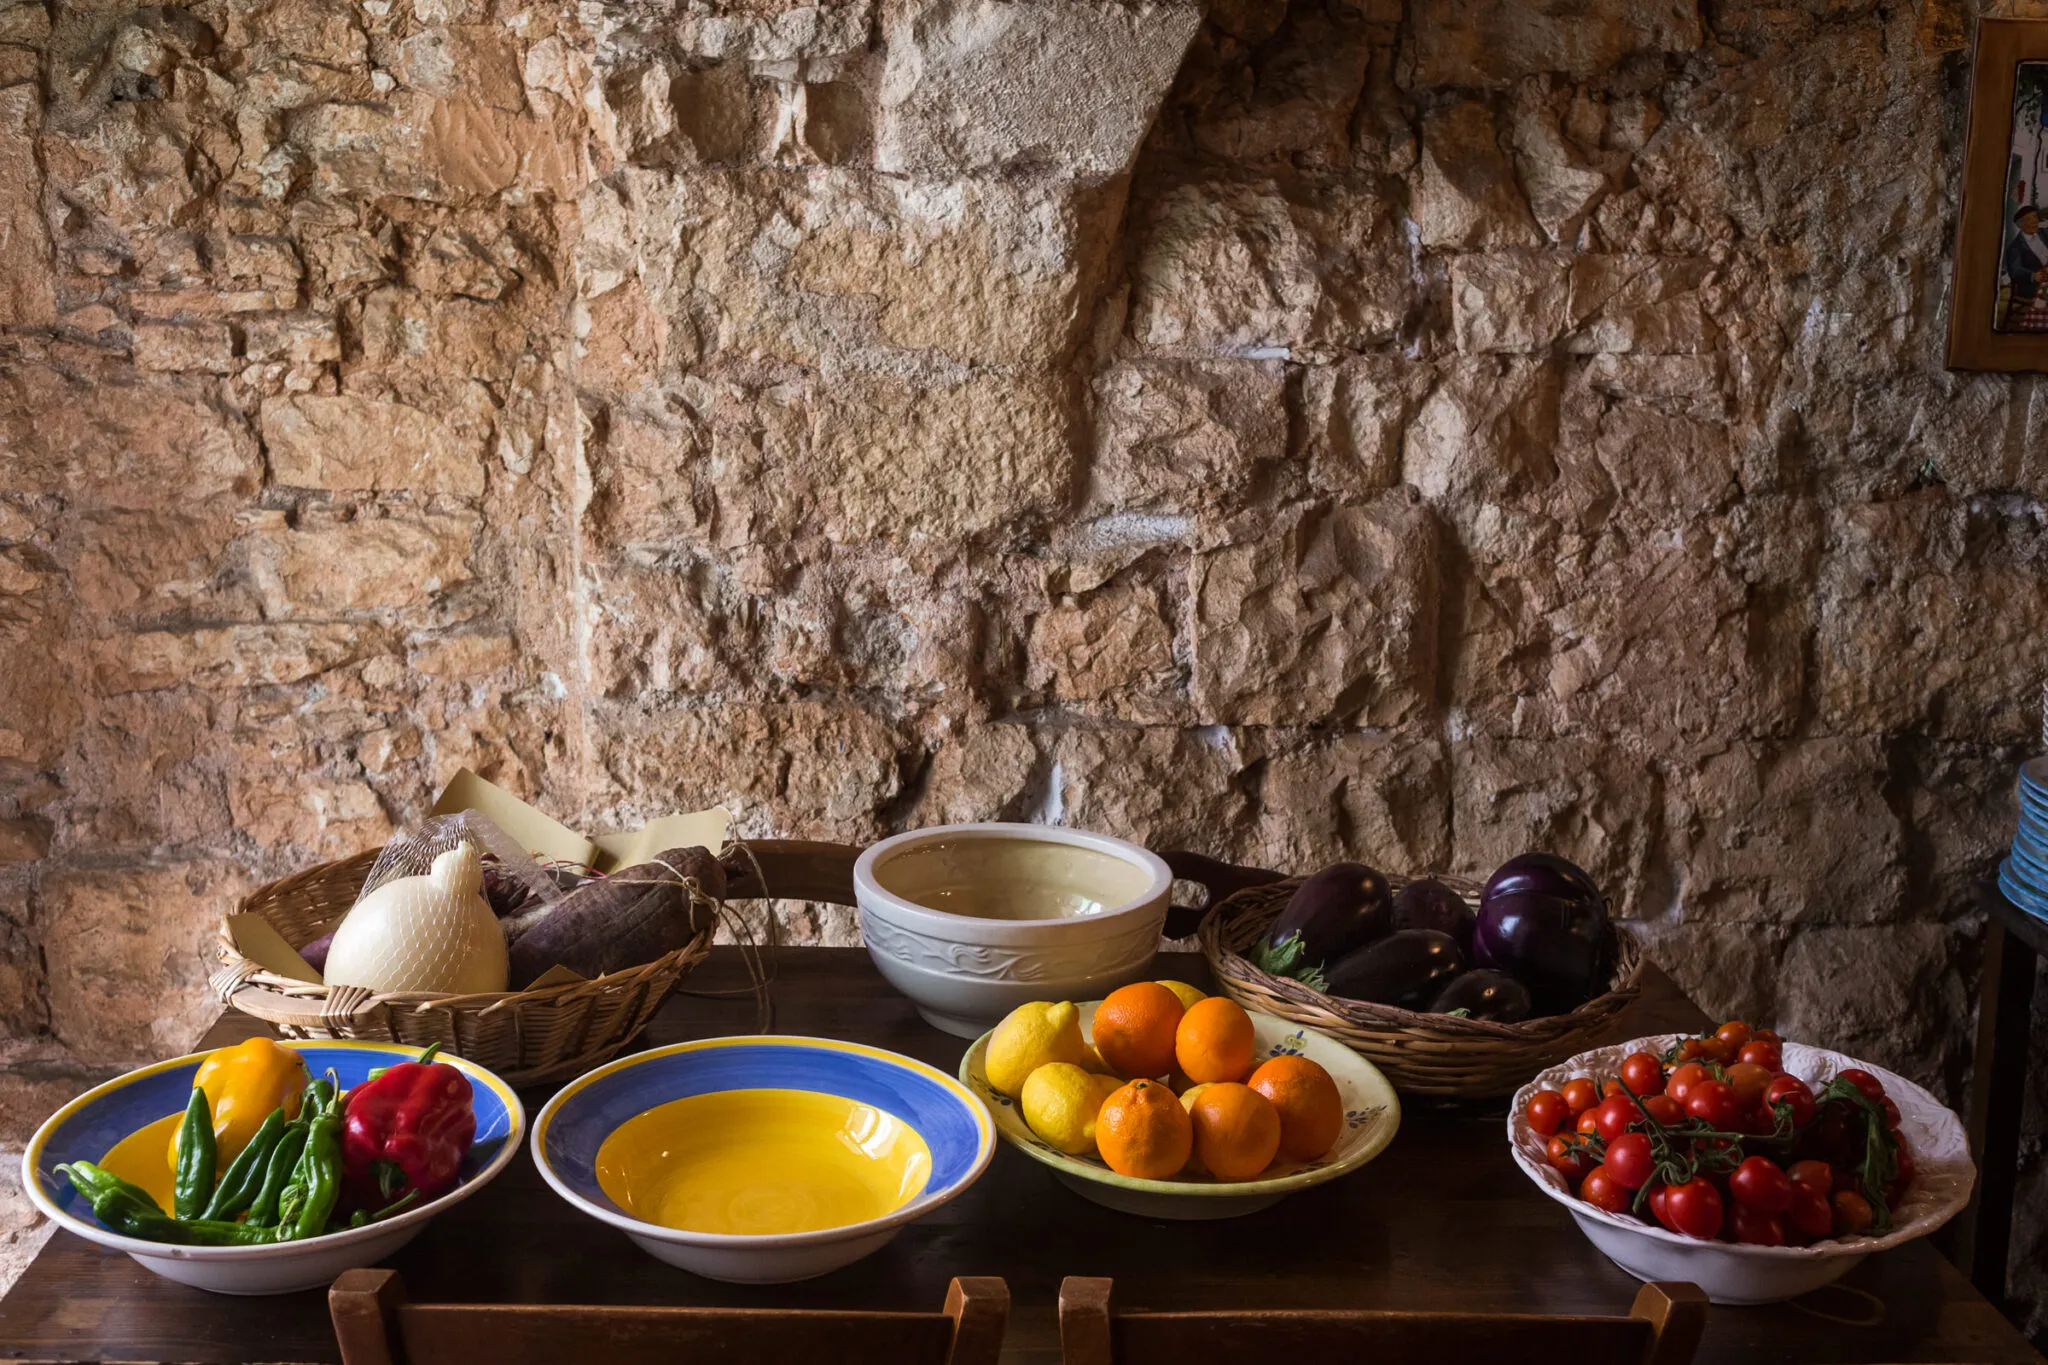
left=1059, top=1277, right=1706, bottom=1365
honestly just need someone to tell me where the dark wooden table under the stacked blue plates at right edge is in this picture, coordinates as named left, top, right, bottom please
left=1956, top=880, right=2048, bottom=1304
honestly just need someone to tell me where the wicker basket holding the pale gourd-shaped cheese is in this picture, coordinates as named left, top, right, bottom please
left=213, top=849, right=711, bottom=1085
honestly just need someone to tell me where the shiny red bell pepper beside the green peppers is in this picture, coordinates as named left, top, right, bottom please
left=342, top=1044, right=477, bottom=1209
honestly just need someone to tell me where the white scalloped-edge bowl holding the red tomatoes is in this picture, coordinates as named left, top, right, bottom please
left=1507, top=1033, right=1976, bottom=1304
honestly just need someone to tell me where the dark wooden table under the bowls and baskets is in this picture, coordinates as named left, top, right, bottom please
left=0, top=948, right=2040, bottom=1365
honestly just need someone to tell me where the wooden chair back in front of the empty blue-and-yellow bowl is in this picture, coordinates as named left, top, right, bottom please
left=328, top=1271, right=1010, bottom=1365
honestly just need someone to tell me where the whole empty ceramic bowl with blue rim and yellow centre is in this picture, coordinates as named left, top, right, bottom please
left=532, top=1038, right=995, bottom=1285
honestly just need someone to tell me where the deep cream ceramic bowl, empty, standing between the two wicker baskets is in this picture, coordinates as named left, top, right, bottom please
left=854, top=825, right=1174, bottom=1038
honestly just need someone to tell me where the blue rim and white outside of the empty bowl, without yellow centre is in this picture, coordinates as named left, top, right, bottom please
left=532, top=1036, right=995, bottom=1285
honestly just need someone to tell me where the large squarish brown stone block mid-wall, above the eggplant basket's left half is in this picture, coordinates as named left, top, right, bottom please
left=1194, top=491, right=1440, bottom=724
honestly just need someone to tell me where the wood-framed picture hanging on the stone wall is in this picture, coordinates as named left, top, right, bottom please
left=1948, top=18, right=2048, bottom=370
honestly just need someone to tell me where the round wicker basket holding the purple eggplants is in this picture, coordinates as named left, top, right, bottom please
left=1196, top=876, right=1642, bottom=1099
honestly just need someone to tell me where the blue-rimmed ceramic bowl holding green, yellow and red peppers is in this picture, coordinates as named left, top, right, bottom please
left=20, top=1040, right=526, bottom=1293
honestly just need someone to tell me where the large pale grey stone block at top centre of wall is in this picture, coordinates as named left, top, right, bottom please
left=874, top=0, right=1202, bottom=176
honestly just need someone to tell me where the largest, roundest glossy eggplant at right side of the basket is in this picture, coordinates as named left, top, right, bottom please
left=1473, top=853, right=1614, bottom=1015
